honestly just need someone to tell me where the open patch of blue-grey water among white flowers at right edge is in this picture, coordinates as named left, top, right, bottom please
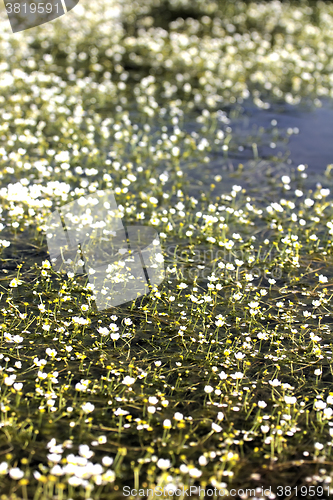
left=185, top=99, right=333, bottom=194
